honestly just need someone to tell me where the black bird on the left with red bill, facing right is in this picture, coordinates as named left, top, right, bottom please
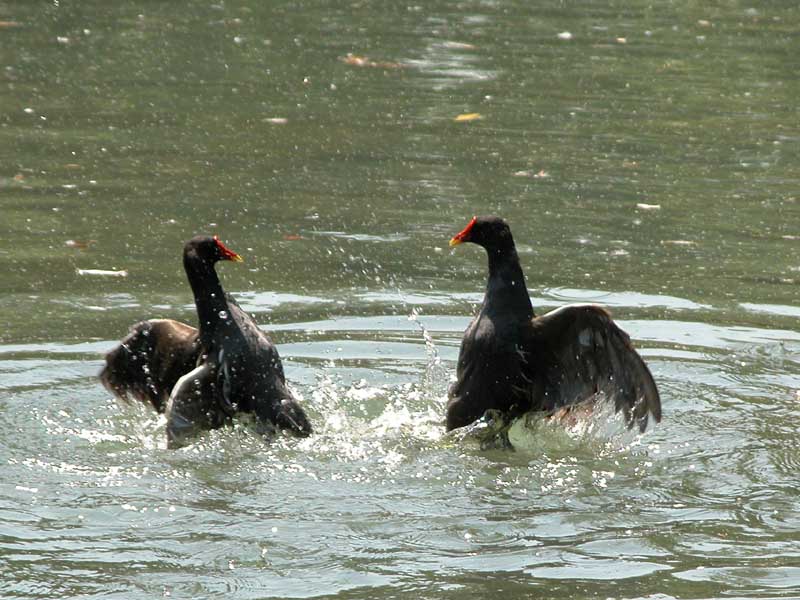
left=100, top=236, right=312, bottom=447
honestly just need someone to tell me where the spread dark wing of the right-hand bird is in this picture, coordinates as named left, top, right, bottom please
left=523, top=304, right=661, bottom=431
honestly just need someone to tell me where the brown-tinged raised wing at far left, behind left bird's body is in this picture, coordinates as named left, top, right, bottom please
left=99, top=319, right=200, bottom=412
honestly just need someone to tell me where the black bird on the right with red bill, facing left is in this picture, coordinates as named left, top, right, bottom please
left=447, top=217, right=661, bottom=431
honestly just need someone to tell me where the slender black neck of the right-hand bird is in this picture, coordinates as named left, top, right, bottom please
left=483, top=245, right=533, bottom=320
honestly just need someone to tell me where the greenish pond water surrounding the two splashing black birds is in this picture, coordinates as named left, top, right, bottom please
left=0, top=0, right=800, bottom=599
